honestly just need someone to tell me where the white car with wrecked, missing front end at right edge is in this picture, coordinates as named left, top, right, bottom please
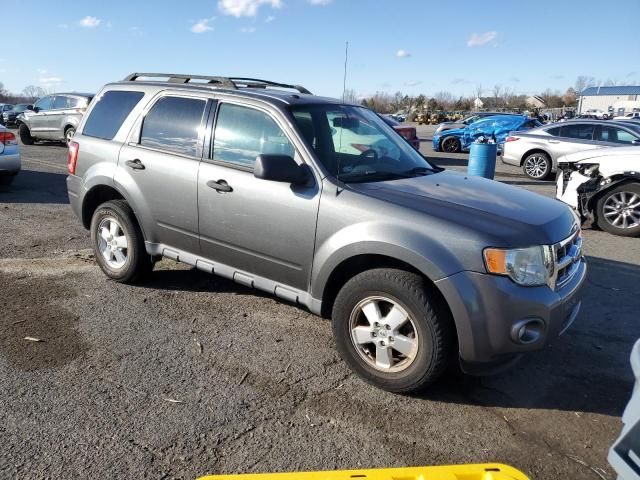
left=556, top=146, right=640, bottom=237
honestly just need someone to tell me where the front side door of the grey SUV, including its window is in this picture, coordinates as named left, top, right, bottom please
left=198, top=103, right=320, bottom=290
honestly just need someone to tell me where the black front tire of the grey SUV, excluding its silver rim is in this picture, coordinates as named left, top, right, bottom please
left=332, top=268, right=455, bottom=393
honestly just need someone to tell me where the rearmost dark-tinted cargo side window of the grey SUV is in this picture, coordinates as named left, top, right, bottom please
left=82, top=90, right=144, bottom=140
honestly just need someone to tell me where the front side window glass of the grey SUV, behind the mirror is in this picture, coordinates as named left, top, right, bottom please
left=213, top=103, right=295, bottom=168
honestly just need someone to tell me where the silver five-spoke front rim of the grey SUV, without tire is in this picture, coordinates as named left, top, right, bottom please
left=349, top=296, right=418, bottom=373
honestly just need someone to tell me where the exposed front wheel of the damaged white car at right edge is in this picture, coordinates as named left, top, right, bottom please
left=596, top=182, right=640, bottom=237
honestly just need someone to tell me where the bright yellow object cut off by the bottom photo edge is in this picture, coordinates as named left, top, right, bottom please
left=199, top=463, right=528, bottom=480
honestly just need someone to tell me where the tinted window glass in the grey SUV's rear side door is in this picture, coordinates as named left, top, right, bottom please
left=140, top=97, right=207, bottom=157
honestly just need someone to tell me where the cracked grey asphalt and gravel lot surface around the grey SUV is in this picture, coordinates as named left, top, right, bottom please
left=0, top=127, right=640, bottom=480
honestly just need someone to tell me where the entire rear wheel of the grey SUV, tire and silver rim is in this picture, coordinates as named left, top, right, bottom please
left=90, top=200, right=153, bottom=283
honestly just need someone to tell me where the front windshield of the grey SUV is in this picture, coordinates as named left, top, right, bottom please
left=291, top=104, right=439, bottom=183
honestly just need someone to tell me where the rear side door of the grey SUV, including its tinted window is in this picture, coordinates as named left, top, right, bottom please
left=114, top=93, right=211, bottom=254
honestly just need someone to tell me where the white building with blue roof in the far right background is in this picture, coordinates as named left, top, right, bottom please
left=578, top=86, right=640, bottom=116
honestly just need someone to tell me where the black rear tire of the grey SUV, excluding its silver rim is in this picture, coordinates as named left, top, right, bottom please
left=89, top=200, right=153, bottom=283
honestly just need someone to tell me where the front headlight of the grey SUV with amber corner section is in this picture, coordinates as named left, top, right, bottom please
left=484, top=245, right=553, bottom=287
